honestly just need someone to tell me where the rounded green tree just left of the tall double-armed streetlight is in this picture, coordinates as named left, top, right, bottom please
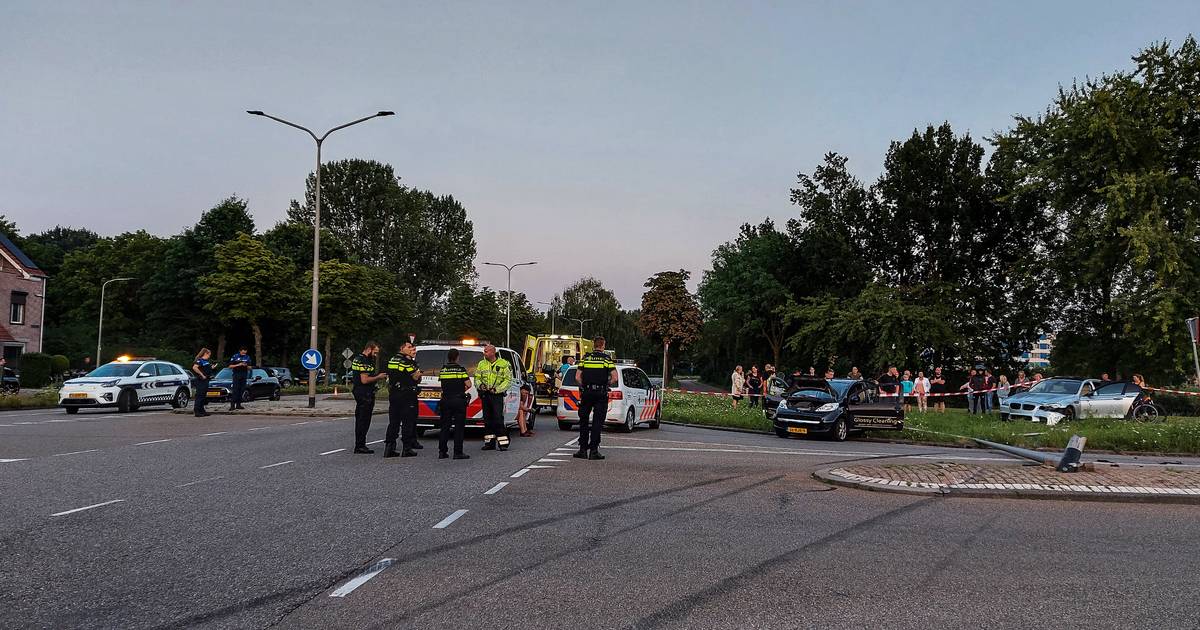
left=199, top=234, right=299, bottom=361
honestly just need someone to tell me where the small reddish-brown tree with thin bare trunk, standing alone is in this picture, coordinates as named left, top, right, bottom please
left=637, top=269, right=704, bottom=384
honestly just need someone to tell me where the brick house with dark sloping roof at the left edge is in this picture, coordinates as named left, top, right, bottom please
left=0, top=234, right=47, bottom=367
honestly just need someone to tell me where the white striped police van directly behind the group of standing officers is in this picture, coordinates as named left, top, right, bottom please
left=416, top=340, right=534, bottom=434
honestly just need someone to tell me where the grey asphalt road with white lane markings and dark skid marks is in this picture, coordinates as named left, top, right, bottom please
left=0, top=410, right=1200, bottom=629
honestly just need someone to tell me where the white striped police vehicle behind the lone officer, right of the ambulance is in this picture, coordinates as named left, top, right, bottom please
left=558, top=365, right=662, bottom=433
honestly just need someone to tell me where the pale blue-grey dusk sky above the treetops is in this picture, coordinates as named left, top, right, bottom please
left=0, top=0, right=1200, bottom=308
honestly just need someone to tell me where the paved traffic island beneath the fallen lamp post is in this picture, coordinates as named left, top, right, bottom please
left=814, top=462, right=1200, bottom=504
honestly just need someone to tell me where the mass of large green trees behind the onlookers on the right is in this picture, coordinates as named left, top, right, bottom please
left=696, top=37, right=1200, bottom=383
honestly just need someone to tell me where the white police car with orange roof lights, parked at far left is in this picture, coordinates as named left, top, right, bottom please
left=59, top=356, right=192, bottom=414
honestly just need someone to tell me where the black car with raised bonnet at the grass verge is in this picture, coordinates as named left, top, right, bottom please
left=774, top=377, right=904, bottom=442
